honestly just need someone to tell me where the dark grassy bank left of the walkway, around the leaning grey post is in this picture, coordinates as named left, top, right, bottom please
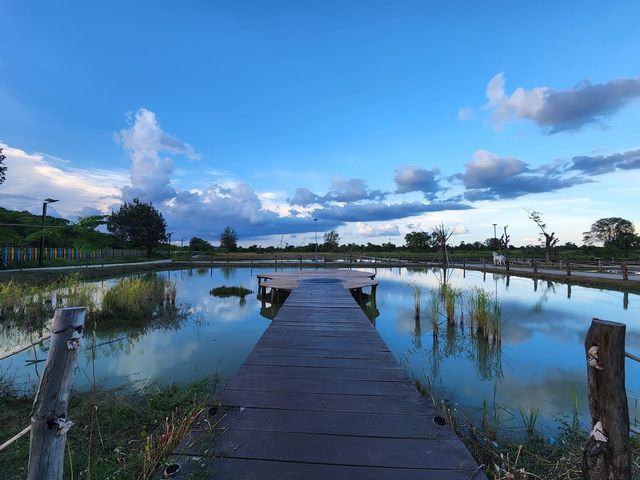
left=0, top=380, right=217, bottom=480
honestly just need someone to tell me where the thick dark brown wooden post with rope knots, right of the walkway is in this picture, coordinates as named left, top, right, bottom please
left=582, top=318, right=631, bottom=480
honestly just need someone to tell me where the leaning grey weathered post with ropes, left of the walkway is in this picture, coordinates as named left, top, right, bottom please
left=27, top=307, right=86, bottom=480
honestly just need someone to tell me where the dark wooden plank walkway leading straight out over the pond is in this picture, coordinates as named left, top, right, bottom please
left=158, top=270, right=486, bottom=480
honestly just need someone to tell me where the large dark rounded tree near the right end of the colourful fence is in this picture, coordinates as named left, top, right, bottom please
left=107, top=198, right=167, bottom=257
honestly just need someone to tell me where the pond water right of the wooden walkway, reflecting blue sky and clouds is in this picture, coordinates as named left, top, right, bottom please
left=377, top=269, right=640, bottom=428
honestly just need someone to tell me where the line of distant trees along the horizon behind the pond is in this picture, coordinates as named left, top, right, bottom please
left=0, top=198, right=640, bottom=260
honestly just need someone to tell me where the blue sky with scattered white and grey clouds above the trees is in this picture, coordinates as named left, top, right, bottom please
left=0, top=0, right=640, bottom=244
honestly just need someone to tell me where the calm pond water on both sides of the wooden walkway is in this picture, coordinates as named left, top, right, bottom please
left=0, top=267, right=640, bottom=433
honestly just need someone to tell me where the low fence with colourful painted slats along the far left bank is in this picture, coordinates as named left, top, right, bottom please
left=0, top=245, right=146, bottom=268
